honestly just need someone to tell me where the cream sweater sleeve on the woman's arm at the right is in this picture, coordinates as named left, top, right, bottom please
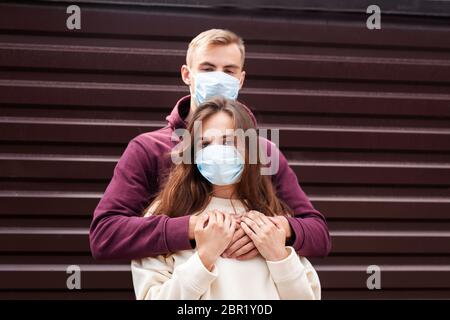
left=267, top=247, right=321, bottom=300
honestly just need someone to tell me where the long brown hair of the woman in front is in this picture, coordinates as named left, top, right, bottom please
left=149, top=98, right=292, bottom=217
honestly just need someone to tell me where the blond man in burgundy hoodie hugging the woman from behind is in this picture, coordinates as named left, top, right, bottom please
left=90, top=29, right=331, bottom=259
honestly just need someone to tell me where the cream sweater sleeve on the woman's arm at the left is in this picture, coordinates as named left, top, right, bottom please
left=131, top=252, right=218, bottom=300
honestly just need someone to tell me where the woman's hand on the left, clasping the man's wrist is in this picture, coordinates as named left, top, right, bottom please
left=194, top=210, right=236, bottom=271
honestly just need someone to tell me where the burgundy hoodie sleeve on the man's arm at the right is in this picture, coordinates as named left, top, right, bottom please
left=267, top=140, right=331, bottom=257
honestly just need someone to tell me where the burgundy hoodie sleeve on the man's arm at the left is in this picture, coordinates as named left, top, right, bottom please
left=89, top=138, right=192, bottom=260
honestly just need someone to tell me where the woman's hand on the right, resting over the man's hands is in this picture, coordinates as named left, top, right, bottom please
left=241, top=210, right=289, bottom=261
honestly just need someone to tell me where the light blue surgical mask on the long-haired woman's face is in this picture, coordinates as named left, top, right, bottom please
left=195, top=144, right=244, bottom=186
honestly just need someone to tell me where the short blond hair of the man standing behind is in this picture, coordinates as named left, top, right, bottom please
left=186, top=29, right=245, bottom=67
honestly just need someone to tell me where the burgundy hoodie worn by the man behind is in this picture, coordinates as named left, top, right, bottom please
left=89, top=96, right=331, bottom=260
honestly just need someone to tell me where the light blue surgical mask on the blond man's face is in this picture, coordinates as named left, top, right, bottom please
left=192, top=71, right=240, bottom=106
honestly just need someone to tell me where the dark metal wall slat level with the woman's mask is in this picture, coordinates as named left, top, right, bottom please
left=0, top=154, right=450, bottom=185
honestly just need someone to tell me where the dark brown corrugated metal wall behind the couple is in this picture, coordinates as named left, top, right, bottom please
left=0, top=3, right=450, bottom=298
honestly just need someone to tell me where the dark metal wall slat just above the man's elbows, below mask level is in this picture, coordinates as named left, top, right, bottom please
left=0, top=190, right=450, bottom=221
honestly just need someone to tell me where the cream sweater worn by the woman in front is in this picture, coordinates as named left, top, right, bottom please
left=131, top=197, right=321, bottom=300
